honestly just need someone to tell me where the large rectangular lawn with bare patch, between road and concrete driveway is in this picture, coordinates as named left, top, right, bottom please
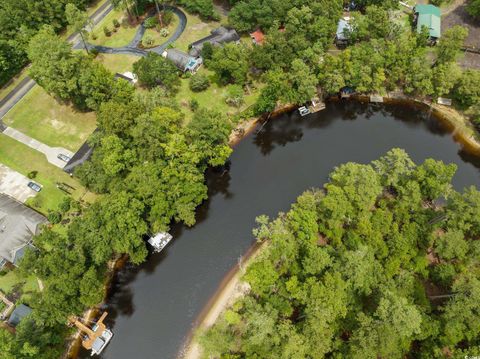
left=3, top=86, right=96, bottom=152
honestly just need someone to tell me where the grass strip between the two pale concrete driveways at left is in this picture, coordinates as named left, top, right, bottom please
left=0, top=134, right=94, bottom=214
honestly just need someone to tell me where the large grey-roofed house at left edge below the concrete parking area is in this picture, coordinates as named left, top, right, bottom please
left=0, top=194, right=47, bottom=269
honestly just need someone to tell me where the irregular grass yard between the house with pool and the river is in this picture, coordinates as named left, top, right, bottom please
left=176, top=67, right=260, bottom=121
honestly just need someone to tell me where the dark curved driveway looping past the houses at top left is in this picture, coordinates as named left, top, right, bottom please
left=73, top=5, right=187, bottom=56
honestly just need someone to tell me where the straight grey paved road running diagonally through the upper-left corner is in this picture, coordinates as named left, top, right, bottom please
left=0, top=1, right=113, bottom=122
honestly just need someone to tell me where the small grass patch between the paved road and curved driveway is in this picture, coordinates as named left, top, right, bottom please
left=88, top=10, right=138, bottom=47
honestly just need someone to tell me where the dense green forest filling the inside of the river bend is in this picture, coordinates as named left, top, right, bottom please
left=200, top=149, right=480, bottom=359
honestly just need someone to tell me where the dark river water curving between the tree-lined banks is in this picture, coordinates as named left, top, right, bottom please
left=82, top=102, right=480, bottom=359
